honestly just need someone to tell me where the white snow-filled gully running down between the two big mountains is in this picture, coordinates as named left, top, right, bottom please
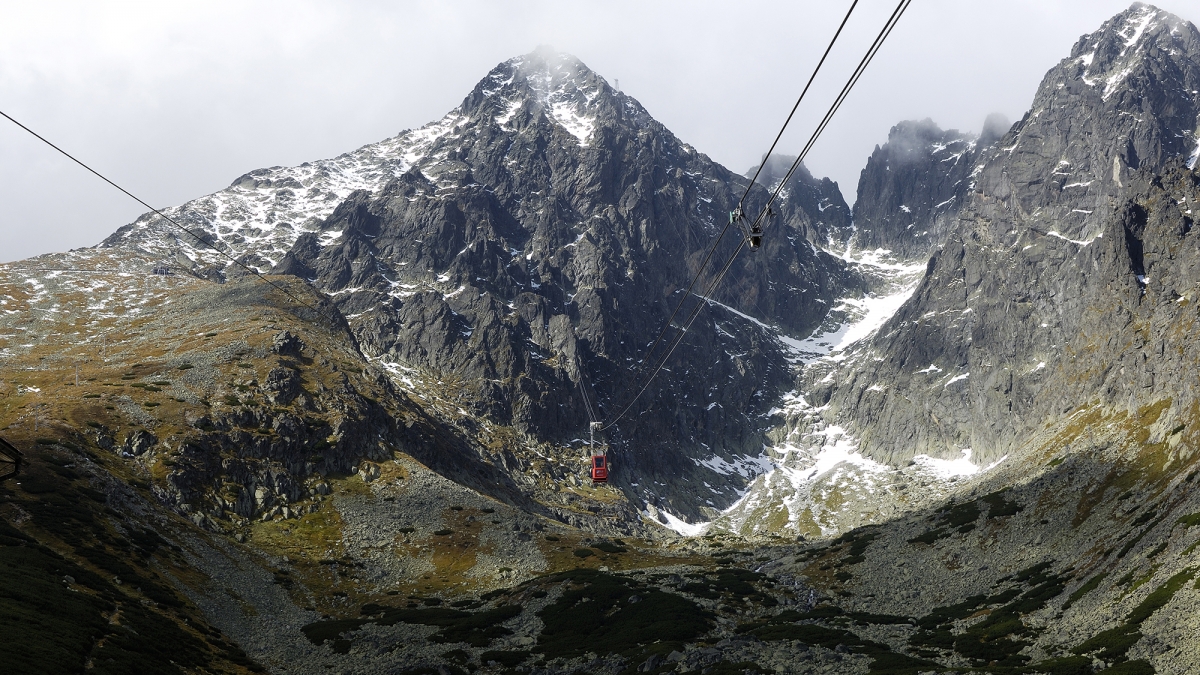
left=646, top=250, right=1003, bottom=536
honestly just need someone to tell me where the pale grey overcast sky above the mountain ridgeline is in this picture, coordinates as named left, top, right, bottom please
left=0, top=0, right=1200, bottom=261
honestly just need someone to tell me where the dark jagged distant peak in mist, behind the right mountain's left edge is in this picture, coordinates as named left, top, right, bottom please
left=853, top=115, right=1008, bottom=259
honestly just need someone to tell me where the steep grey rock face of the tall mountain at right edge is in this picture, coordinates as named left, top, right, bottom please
left=810, top=5, right=1200, bottom=464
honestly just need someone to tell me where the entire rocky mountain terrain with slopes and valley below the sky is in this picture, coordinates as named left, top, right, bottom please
left=0, top=2, right=1200, bottom=675
